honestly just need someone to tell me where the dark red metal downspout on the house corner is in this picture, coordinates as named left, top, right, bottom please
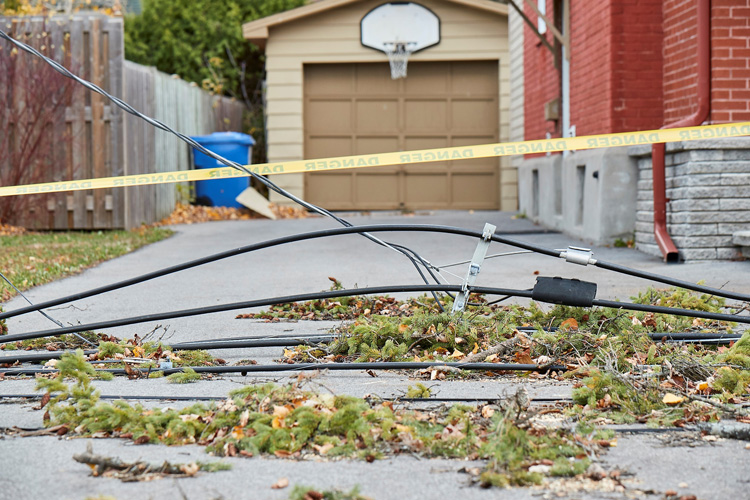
left=651, top=0, right=711, bottom=262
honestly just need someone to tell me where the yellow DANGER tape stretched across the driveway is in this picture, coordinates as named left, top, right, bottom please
left=0, top=122, right=750, bottom=196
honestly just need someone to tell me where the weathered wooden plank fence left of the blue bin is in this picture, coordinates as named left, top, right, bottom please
left=0, top=14, right=243, bottom=229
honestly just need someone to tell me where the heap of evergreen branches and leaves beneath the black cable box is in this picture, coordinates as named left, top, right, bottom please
left=268, top=289, right=750, bottom=425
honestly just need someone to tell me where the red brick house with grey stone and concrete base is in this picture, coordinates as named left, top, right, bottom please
left=512, top=0, right=750, bottom=260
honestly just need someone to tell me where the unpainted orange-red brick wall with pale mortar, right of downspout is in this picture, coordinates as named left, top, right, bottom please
left=711, top=0, right=750, bottom=123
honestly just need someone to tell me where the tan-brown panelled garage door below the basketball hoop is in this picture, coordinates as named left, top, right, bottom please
left=304, top=61, right=500, bottom=210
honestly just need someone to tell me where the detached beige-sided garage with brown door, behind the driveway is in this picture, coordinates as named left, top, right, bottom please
left=243, top=0, right=517, bottom=210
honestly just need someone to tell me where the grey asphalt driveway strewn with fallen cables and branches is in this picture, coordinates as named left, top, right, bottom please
left=0, top=212, right=750, bottom=500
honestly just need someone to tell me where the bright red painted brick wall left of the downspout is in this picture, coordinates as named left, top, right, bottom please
left=524, top=0, right=668, bottom=143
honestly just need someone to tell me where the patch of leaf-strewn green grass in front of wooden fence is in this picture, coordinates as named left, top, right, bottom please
left=0, top=226, right=172, bottom=301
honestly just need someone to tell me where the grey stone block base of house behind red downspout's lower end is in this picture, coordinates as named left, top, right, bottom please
left=629, top=138, right=750, bottom=261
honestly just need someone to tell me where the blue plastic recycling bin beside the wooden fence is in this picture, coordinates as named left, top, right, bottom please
left=192, top=132, right=255, bottom=208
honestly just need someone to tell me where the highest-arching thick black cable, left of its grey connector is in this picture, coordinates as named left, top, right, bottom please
left=0, top=224, right=560, bottom=320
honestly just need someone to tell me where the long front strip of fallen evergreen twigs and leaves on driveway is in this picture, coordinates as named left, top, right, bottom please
left=38, top=352, right=609, bottom=486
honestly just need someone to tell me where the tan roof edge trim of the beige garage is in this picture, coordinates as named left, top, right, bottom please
left=242, top=0, right=508, bottom=48
